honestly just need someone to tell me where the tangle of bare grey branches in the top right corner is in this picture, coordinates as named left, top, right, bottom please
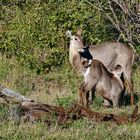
left=86, top=0, right=140, bottom=49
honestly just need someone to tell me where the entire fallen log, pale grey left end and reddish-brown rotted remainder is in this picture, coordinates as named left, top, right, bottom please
left=0, top=87, right=139, bottom=125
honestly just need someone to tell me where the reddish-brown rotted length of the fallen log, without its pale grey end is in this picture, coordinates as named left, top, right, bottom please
left=22, top=102, right=139, bottom=124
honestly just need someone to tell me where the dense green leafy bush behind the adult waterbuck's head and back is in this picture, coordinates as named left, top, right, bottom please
left=0, top=0, right=122, bottom=73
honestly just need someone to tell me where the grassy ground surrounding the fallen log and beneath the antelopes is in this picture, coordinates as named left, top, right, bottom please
left=0, top=57, right=140, bottom=140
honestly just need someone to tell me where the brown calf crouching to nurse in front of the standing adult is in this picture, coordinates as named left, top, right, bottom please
left=79, top=47, right=124, bottom=107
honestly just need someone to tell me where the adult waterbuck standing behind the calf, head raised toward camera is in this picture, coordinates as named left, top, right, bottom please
left=66, top=30, right=134, bottom=104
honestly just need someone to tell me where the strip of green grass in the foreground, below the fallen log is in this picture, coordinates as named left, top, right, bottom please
left=0, top=120, right=140, bottom=140
